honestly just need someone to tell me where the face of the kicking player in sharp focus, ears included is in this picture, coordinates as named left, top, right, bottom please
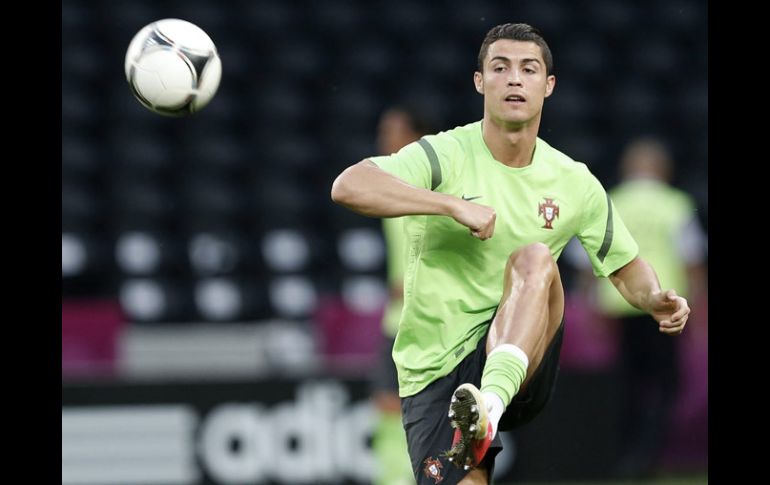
left=473, top=39, right=556, bottom=125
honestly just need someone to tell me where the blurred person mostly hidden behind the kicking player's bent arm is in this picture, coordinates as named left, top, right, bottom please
left=372, top=105, right=435, bottom=485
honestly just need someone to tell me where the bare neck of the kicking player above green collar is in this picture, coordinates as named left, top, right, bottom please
left=481, top=116, right=540, bottom=168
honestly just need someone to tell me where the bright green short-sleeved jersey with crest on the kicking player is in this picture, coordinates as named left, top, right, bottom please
left=370, top=121, right=637, bottom=397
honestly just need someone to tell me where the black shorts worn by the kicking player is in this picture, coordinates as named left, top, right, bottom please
left=401, top=320, right=564, bottom=485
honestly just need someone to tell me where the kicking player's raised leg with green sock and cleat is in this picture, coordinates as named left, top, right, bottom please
left=447, top=243, right=564, bottom=474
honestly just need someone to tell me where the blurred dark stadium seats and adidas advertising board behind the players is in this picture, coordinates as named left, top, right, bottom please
left=62, top=0, right=708, bottom=483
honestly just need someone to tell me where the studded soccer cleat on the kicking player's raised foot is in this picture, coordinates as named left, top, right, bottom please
left=444, top=384, right=493, bottom=470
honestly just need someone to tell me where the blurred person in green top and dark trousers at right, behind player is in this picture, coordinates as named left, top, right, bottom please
left=568, top=137, right=706, bottom=478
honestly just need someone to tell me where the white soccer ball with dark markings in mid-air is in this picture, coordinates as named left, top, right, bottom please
left=125, top=19, right=222, bottom=117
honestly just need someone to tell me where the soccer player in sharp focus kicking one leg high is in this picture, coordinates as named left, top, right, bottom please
left=331, top=24, right=690, bottom=485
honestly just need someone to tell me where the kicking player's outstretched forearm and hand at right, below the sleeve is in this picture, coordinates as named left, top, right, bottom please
left=609, top=256, right=690, bottom=335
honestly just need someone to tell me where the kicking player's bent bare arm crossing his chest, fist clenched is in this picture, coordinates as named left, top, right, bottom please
left=331, top=160, right=495, bottom=239
